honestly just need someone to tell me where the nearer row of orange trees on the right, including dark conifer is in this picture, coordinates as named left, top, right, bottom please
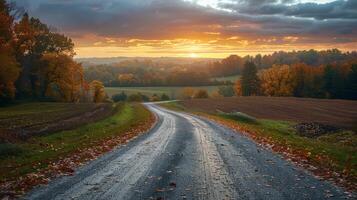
left=234, top=61, right=357, bottom=99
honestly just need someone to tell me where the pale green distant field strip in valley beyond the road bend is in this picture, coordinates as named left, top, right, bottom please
left=105, top=86, right=219, bottom=99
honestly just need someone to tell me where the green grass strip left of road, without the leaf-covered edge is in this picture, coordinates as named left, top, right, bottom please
left=0, top=104, right=151, bottom=179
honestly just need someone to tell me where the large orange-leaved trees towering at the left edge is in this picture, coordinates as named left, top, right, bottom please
left=0, top=0, right=104, bottom=104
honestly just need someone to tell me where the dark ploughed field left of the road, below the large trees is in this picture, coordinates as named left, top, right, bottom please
left=0, top=103, right=113, bottom=142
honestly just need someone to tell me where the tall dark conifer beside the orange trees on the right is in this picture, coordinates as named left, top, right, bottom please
left=241, top=61, right=259, bottom=96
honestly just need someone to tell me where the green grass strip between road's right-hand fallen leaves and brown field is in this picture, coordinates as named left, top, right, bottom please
left=163, top=102, right=357, bottom=178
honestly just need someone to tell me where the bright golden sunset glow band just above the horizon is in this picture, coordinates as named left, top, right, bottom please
left=75, top=36, right=357, bottom=58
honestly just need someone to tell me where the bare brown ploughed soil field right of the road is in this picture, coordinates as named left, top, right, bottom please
left=181, top=97, right=357, bottom=130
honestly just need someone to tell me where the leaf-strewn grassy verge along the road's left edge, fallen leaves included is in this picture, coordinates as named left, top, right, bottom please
left=0, top=104, right=155, bottom=197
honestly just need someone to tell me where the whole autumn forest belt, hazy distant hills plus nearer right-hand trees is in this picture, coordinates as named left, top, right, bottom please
left=84, top=49, right=357, bottom=99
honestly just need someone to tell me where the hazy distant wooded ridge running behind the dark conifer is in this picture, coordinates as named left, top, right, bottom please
left=84, top=49, right=357, bottom=87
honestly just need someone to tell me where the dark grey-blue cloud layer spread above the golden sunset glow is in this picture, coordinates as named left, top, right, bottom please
left=11, top=0, right=357, bottom=44
